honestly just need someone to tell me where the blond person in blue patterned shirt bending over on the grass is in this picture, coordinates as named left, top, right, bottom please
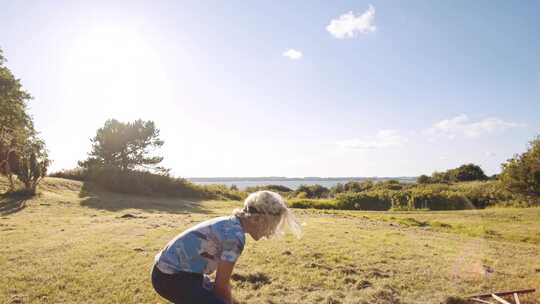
left=152, top=191, right=301, bottom=304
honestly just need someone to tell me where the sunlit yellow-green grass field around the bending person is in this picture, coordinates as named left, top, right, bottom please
left=0, top=178, right=540, bottom=303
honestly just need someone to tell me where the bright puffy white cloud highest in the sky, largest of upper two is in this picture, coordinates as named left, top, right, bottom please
left=326, top=5, right=377, bottom=39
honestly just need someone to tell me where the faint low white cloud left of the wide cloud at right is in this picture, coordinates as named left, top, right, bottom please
left=337, top=130, right=407, bottom=150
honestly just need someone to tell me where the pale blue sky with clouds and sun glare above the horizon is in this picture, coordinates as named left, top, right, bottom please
left=0, top=1, right=540, bottom=177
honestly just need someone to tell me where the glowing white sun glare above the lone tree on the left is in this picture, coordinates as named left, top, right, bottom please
left=62, top=28, right=171, bottom=123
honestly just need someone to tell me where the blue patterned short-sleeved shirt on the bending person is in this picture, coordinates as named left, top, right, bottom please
left=155, top=216, right=246, bottom=274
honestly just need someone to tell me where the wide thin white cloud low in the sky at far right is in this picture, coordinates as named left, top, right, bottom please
left=427, top=114, right=522, bottom=138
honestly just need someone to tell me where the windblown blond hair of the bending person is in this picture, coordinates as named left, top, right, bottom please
left=233, top=190, right=302, bottom=238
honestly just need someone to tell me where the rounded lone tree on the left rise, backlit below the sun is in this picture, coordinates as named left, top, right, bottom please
left=79, top=119, right=164, bottom=171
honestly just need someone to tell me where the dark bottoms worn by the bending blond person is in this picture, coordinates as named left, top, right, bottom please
left=152, top=265, right=225, bottom=304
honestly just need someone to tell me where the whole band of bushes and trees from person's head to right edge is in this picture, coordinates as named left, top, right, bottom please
left=246, top=137, right=540, bottom=210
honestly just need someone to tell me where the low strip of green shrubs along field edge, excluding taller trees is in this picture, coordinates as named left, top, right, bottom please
left=289, top=181, right=516, bottom=210
